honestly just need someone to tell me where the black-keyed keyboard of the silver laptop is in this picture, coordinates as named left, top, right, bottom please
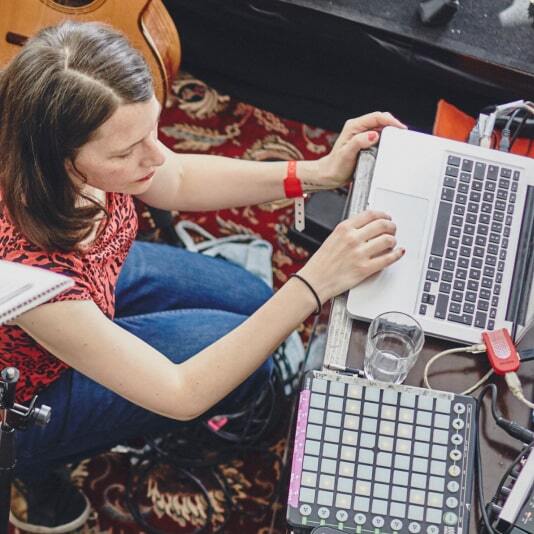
left=419, top=154, right=520, bottom=330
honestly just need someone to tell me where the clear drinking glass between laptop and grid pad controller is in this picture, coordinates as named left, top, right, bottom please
left=364, top=312, right=425, bottom=384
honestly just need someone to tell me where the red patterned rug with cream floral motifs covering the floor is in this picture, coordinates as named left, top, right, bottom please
left=13, top=73, right=335, bottom=534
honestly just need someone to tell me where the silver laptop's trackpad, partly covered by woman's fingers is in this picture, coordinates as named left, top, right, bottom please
left=370, top=188, right=428, bottom=263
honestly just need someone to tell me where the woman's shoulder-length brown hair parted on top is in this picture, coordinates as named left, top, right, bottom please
left=0, top=21, right=153, bottom=251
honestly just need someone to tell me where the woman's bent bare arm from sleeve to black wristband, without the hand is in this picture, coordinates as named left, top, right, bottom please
left=17, top=280, right=315, bottom=420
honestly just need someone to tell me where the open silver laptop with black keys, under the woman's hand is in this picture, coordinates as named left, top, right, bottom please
left=347, top=127, right=534, bottom=343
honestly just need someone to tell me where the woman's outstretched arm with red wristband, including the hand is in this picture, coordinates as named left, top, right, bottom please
left=139, top=112, right=404, bottom=211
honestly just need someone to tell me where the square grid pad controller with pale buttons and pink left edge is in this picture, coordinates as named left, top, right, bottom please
left=287, top=371, right=475, bottom=534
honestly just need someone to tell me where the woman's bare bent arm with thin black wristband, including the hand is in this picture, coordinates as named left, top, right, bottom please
left=17, top=212, right=402, bottom=420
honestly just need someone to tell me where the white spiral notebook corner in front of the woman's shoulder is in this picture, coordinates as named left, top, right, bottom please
left=0, top=260, right=74, bottom=325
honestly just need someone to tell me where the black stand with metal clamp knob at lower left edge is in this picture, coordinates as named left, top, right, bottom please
left=0, top=367, right=52, bottom=534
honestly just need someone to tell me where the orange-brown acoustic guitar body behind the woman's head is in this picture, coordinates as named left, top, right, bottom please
left=0, top=0, right=181, bottom=105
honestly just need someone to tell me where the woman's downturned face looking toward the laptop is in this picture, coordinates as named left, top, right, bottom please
left=67, top=97, right=165, bottom=195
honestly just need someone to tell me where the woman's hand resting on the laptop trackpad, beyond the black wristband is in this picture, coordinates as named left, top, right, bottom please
left=300, top=211, right=405, bottom=302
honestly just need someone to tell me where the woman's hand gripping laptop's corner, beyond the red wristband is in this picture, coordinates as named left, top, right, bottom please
left=304, top=111, right=406, bottom=191
